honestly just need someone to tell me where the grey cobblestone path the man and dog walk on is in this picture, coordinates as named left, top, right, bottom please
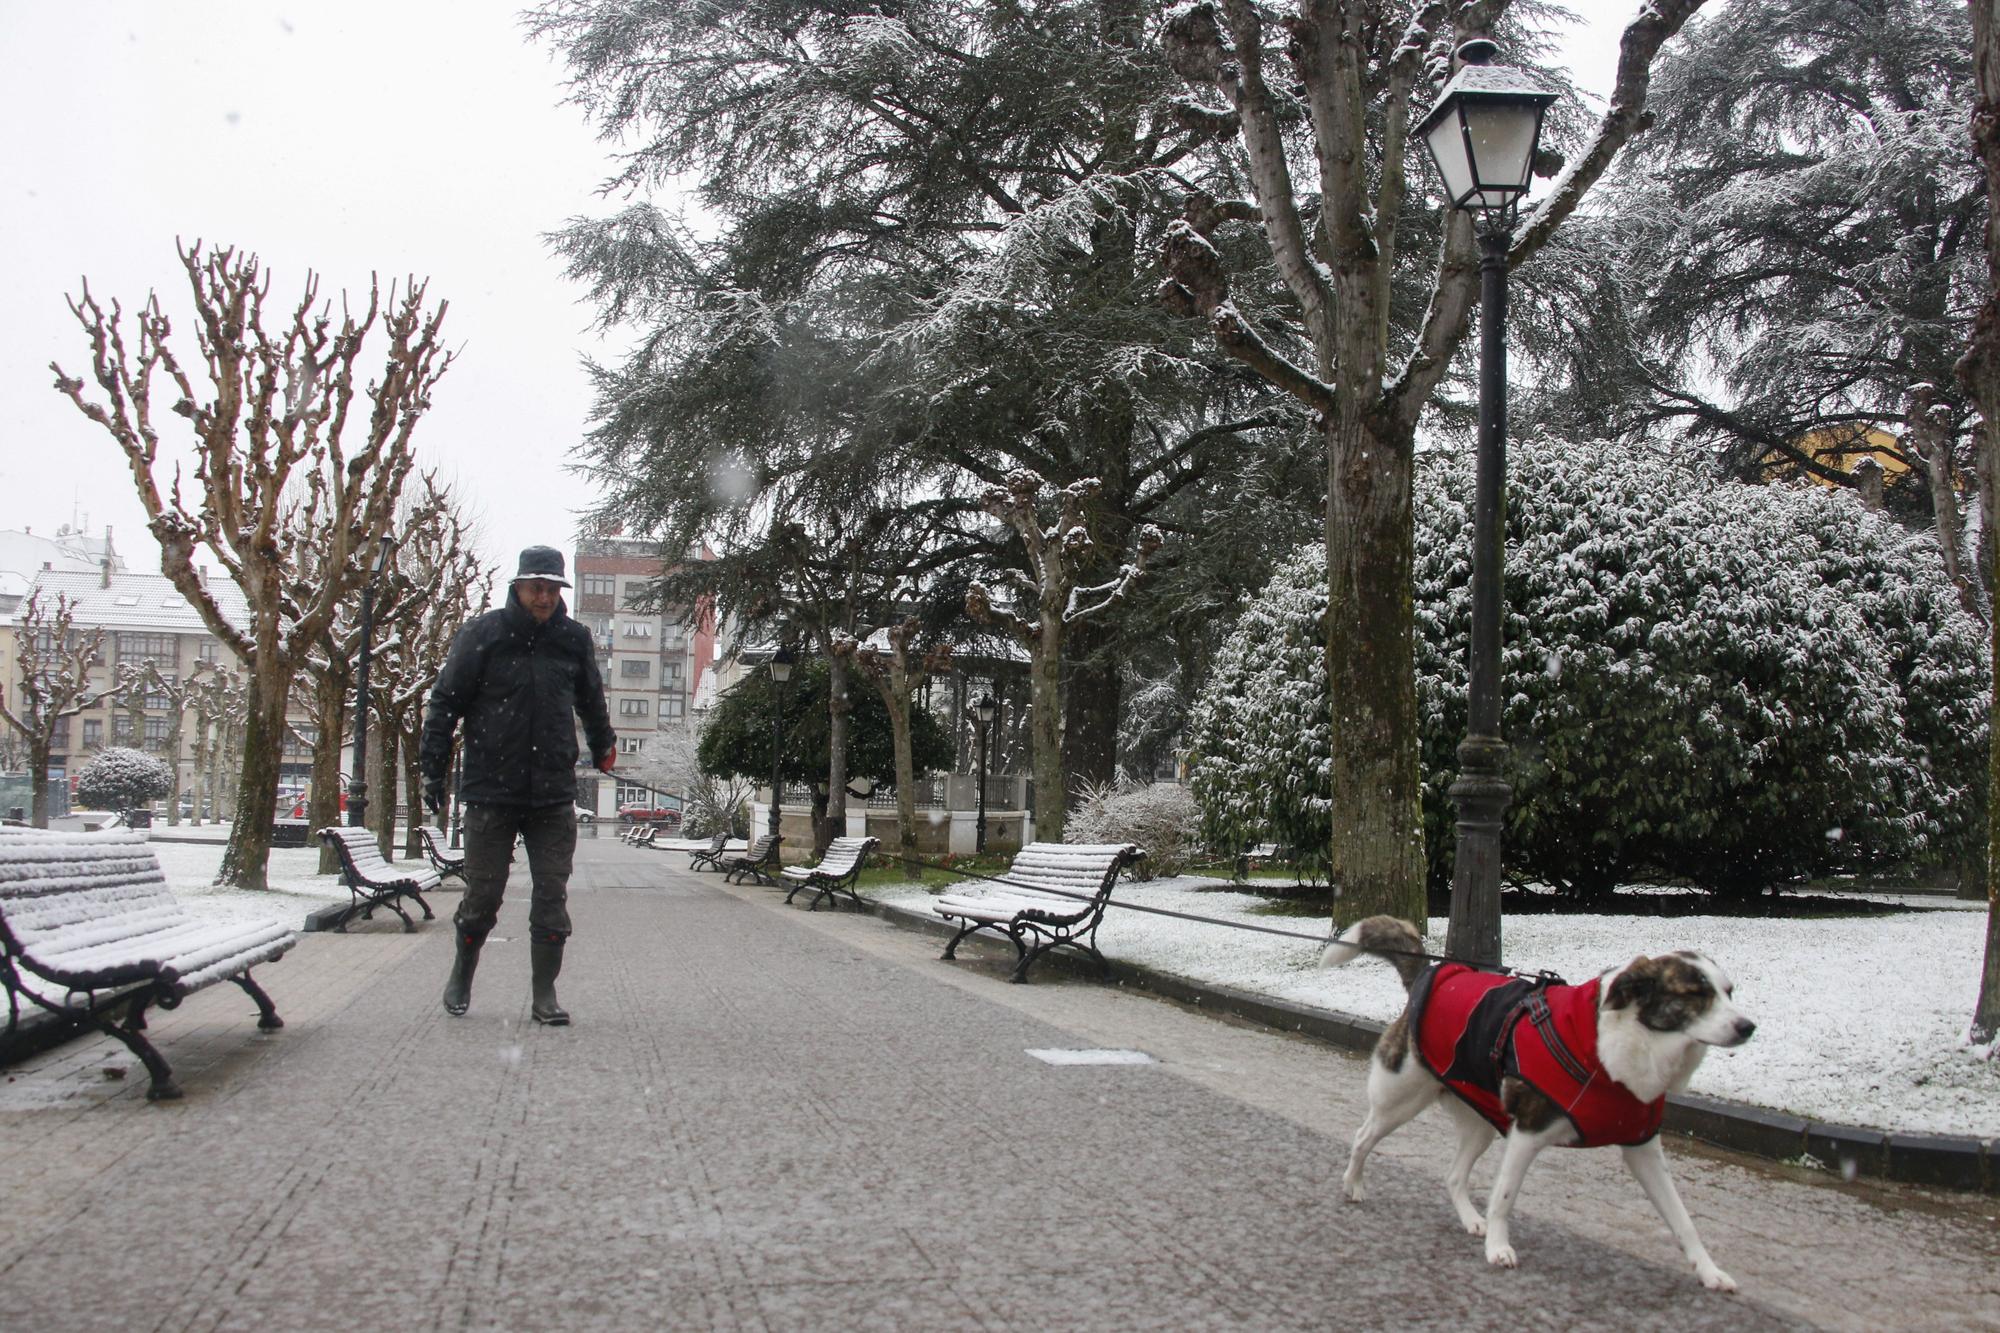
left=0, top=839, right=2000, bottom=1333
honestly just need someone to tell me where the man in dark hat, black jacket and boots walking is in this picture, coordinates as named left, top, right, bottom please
left=420, top=546, right=618, bottom=1027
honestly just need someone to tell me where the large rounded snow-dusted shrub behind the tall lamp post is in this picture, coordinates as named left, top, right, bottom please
left=1190, top=442, right=1990, bottom=897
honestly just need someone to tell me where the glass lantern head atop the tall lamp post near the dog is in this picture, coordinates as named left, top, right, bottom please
left=1416, top=40, right=1556, bottom=212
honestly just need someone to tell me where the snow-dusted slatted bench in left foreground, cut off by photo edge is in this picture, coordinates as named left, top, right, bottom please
left=0, top=829, right=298, bottom=1101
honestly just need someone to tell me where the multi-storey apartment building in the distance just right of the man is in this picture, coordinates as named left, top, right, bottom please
left=570, top=536, right=716, bottom=819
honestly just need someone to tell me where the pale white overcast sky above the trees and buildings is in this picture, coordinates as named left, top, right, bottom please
left=0, top=0, right=1636, bottom=592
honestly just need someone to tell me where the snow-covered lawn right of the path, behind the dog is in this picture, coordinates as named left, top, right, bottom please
left=862, top=877, right=2000, bottom=1139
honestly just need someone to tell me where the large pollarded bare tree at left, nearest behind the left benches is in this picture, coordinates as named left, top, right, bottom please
left=52, top=242, right=452, bottom=889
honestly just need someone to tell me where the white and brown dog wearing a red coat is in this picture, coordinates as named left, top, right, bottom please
left=1320, top=917, right=1756, bottom=1291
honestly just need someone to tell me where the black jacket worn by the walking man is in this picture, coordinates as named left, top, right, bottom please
left=420, top=588, right=618, bottom=805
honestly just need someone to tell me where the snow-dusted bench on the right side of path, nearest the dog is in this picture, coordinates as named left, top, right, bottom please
left=930, top=843, right=1146, bottom=981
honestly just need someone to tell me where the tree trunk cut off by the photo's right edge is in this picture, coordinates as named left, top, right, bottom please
left=1958, top=0, right=2000, bottom=1043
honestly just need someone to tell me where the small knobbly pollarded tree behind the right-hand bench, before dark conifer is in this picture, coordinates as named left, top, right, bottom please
left=966, top=468, right=1160, bottom=843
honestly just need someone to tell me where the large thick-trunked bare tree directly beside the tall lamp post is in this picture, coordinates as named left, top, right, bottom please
left=1162, top=0, right=1702, bottom=919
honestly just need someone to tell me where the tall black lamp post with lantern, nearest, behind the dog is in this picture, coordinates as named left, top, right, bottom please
left=1416, top=38, right=1556, bottom=965
